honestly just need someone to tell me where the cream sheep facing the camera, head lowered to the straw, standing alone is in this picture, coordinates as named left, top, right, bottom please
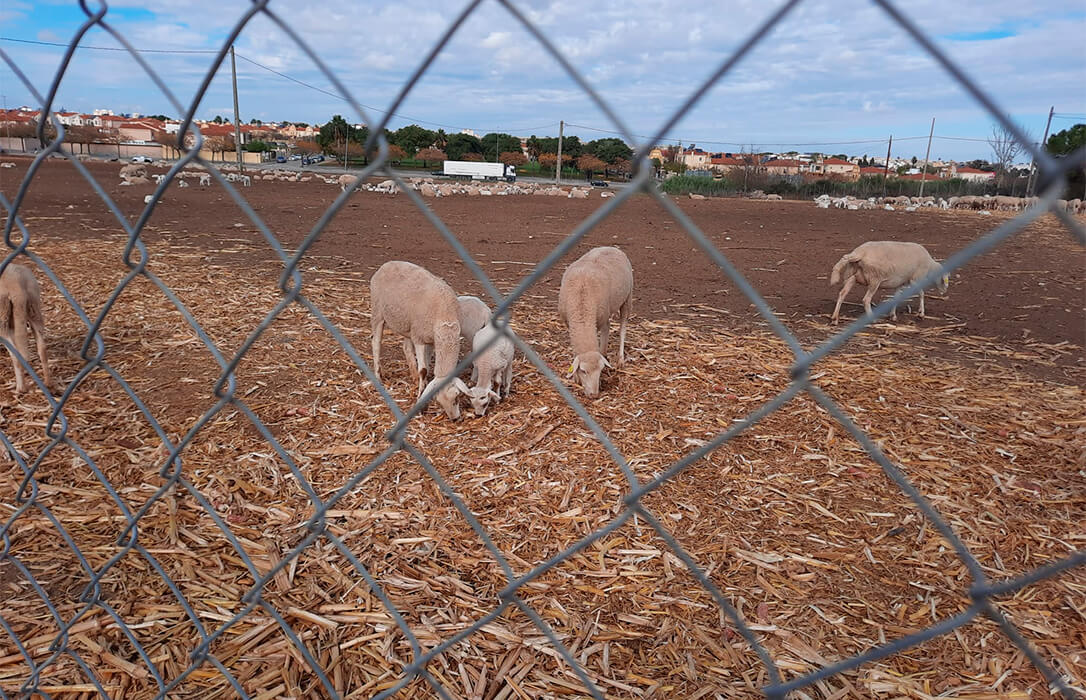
left=558, top=246, right=633, bottom=398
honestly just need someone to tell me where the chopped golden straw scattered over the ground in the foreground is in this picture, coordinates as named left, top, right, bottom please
left=0, top=234, right=1086, bottom=700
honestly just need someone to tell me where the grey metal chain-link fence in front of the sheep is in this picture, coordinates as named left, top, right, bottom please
left=0, top=0, right=1086, bottom=698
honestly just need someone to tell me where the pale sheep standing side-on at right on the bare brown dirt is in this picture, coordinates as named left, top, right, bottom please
left=830, top=241, right=950, bottom=324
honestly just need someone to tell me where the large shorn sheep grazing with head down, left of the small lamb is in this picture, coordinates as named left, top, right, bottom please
left=369, top=260, right=469, bottom=420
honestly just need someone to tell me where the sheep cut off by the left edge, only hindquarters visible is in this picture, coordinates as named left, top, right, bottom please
left=0, top=263, right=52, bottom=394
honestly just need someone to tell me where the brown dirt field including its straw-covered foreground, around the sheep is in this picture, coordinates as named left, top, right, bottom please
left=0, top=161, right=1086, bottom=700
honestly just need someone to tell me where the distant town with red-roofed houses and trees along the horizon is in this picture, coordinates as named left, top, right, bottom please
left=0, top=106, right=1030, bottom=182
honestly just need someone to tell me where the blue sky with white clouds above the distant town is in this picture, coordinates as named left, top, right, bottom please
left=0, top=0, right=1086, bottom=160
